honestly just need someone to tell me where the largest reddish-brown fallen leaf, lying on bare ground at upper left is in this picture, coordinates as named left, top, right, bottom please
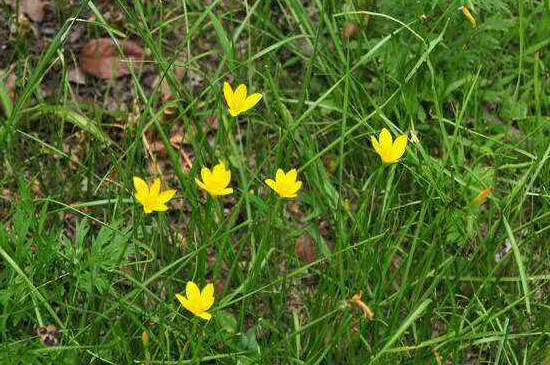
left=80, top=38, right=144, bottom=79
